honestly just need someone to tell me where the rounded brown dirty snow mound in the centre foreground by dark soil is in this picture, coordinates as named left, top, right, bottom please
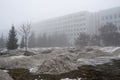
left=37, top=59, right=75, bottom=74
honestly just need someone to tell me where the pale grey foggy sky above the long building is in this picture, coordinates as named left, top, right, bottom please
left=0, top=0, right=120, bottom=30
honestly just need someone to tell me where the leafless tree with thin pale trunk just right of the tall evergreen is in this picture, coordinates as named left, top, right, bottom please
left=20, top=23, right=31, bottom=51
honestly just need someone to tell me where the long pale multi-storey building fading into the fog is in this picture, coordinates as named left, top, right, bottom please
left=34, top=7, right=120, bottom=45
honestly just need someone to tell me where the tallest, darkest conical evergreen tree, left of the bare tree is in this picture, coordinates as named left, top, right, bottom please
left=7, top=26, right=18, bottom=50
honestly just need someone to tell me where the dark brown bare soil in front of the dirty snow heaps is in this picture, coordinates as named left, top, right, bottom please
left=0, top=60, right=120, bottom=80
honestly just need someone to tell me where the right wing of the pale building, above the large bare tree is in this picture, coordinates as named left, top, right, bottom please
left=97, top=7, right=120, bottom=31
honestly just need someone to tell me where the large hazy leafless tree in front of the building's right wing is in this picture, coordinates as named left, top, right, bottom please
left=99, top=23, right=120, bottom=46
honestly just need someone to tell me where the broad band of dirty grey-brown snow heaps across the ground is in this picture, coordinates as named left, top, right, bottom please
left=0, top=47, right=120, bottom=74
